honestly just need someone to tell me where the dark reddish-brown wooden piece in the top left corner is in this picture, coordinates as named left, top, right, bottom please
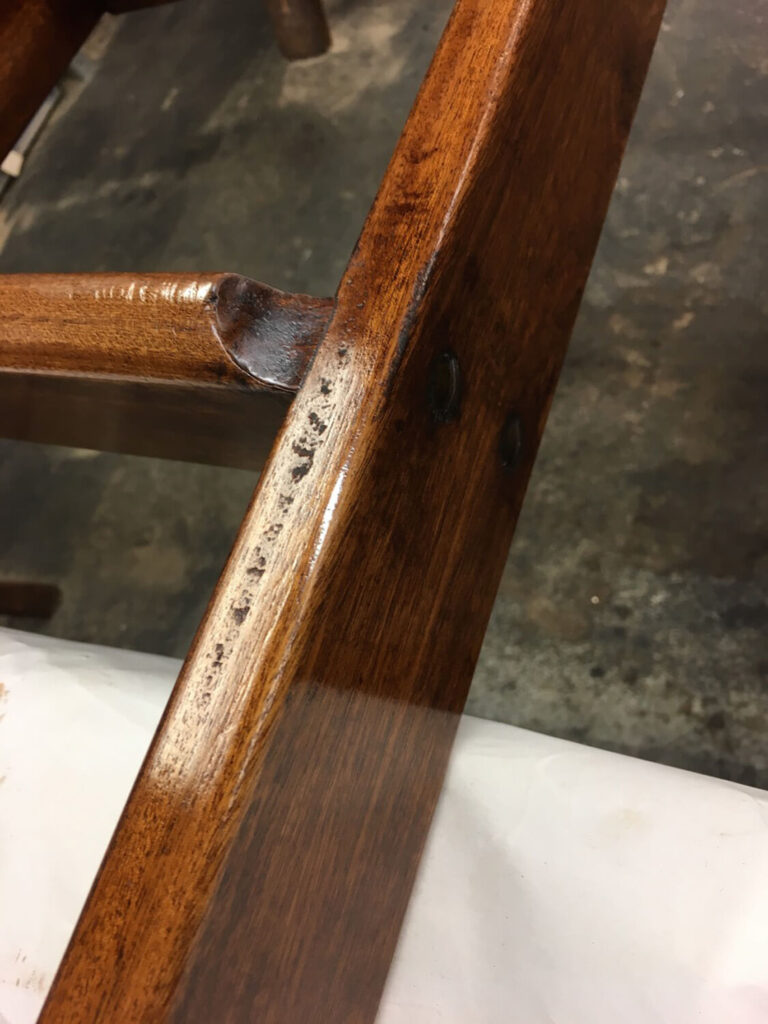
left=0, top=0, right=103, bottom=160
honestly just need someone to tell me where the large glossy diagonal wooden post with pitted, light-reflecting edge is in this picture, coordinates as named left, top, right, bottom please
left=41, top=0, right=662, bottom=1024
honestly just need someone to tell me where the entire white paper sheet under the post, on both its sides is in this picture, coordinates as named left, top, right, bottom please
left=0, top=630, right=768, bottom=1024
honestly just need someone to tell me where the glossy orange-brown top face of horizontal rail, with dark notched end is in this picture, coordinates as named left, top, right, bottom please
left=0, top=273, right=333, bottom=391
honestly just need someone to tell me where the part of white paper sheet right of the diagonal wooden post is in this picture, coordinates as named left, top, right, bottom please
left=378, top=718, right=768, bottom=1024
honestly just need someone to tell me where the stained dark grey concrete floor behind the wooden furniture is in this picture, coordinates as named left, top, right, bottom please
left=0, top=0, right=768, bottom=786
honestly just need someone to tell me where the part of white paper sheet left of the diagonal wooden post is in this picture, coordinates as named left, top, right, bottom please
left=0, top=630, right=178, bottom=1024
